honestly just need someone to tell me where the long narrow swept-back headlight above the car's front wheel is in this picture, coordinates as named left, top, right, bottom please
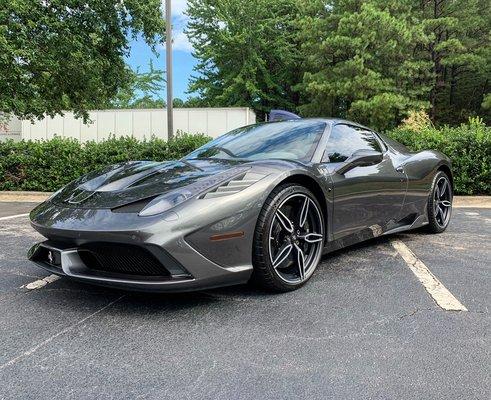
left=138, top=168, right=249, bottom=217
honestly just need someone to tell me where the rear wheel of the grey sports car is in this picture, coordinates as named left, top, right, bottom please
left=427, top=171, right=453, bottom=233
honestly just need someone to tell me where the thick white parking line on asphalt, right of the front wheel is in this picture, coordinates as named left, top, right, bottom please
left=391, top=240, right=467, bottom=311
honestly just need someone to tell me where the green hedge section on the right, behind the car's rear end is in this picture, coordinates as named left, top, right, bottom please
left=387, top=119, right=491, bottom=195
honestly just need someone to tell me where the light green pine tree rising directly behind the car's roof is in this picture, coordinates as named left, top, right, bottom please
left=298, top=0, right=430, bottom=129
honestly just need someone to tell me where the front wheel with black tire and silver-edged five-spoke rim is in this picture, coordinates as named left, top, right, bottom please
left=253, top=184, right=324, bottom=291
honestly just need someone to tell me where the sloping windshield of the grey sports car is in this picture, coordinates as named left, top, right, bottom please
left=186, top=120, right=326, bottom=162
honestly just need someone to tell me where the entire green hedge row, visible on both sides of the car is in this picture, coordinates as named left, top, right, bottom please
left=0, top=120, right=491, bottom=194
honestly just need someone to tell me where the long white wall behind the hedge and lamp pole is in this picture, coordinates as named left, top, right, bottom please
left=22, top=108, right=256, bottom=142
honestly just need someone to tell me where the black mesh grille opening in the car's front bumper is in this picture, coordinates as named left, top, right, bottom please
left=78, top=243, right=170, bottom=277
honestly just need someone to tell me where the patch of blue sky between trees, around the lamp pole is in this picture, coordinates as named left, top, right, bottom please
left=127, top=0, right=196, bottom=100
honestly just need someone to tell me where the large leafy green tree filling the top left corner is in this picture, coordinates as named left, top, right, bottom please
left=0, top=0, right=164, bottom=118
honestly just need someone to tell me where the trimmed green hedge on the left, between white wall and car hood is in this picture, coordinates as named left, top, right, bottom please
left=0, top=135, right=210, bottom=191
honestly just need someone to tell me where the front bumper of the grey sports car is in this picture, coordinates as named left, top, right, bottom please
left=28, top=198, right=258, bottom=292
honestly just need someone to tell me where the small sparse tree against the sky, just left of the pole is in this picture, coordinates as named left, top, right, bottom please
left=107, top=60, right=165, bottom=108
